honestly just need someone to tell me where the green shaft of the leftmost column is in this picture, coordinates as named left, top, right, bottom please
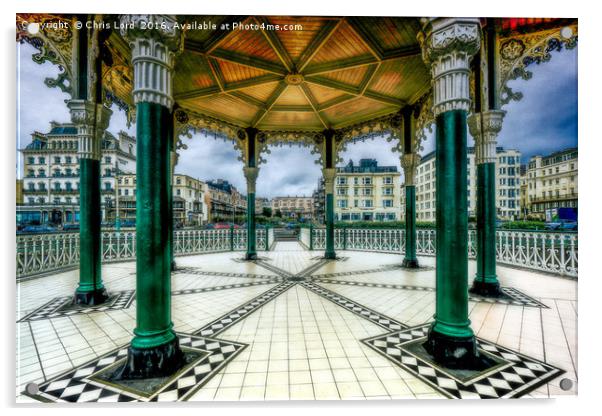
left=76, top=158, right=104, bottom=294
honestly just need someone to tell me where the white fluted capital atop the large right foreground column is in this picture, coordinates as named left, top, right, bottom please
left=418, top=18, right=481, bottom=117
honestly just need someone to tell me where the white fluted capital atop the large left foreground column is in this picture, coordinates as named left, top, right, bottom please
left=120, top=14, right=183, bottom=110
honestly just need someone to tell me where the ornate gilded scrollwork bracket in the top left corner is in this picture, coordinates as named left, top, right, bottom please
left=16, top=13, right=72, bottom=94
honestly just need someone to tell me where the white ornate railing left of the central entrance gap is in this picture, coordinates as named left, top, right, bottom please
left=16, top=229, right=273, bottom=278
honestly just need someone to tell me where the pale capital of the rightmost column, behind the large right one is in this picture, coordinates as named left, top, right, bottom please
left=467, top=110, right=506, bottom=165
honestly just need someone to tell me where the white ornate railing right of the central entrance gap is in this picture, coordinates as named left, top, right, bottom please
left=310, top=228, right=578, bottom=277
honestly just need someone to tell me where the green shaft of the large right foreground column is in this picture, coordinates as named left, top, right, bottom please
left=431, top=110, right=474, bottom=339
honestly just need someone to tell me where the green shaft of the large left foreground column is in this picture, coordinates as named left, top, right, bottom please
left=131, top=102, right=176, bottom=349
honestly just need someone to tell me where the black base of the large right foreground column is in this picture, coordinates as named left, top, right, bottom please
left=423, top=327, right=490, bottom=370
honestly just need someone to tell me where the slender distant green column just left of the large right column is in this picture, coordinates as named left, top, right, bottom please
left=401, top=153, right=420, bottom=269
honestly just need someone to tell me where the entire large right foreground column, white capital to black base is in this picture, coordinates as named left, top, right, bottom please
left=419, top=18, right=481, bottom=369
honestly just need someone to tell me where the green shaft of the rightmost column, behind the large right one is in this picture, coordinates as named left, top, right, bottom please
left=475, top=163, right=499, bottom=285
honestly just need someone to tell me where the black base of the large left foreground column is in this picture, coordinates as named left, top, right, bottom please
left=117, top=337, right=185, bottom=380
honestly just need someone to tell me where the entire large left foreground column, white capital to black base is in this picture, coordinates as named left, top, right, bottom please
left=121, top=15, right=184, bottom=379
